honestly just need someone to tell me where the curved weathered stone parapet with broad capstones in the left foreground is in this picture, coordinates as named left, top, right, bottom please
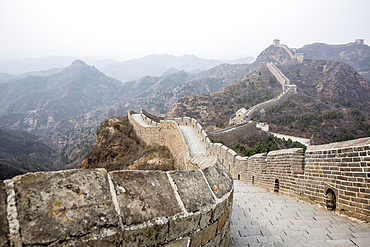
left=0, top=157, right=233, bottom=247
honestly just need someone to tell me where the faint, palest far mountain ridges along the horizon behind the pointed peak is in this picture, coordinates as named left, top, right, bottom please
left=0, top=54, right=254, bottom=82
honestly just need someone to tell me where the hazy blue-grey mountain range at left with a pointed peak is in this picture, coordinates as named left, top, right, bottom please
left=0, top=60, right=250, bottom=169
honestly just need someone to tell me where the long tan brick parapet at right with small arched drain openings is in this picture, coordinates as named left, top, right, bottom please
left=230, top=138, right=370, bottom=222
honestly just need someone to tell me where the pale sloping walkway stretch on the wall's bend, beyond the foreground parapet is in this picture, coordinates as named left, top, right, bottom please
left=179, top=125, right=207, bottom=157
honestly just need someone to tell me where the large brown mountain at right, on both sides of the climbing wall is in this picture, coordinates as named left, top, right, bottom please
left=166, top=46, right=370, bottom=144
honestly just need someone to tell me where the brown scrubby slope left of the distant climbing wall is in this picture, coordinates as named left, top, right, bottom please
left=166, top=67, right=282, bottom=127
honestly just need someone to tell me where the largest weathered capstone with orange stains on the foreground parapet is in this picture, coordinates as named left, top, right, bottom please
left=13, top=169, right=118, bottom=245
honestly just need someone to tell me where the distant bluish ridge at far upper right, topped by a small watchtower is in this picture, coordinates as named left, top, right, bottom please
left=297, top=42, right=370, bottom=82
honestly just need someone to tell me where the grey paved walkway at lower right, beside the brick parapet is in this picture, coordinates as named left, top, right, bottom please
left=230, top=180, right=370, bottom=247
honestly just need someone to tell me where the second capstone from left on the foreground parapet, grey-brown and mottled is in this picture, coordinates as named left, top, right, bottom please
left=109, top=171, right=182, bottom=225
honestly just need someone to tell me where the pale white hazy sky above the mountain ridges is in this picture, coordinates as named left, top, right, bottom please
left=0, top=0, right=370, bottom=60
